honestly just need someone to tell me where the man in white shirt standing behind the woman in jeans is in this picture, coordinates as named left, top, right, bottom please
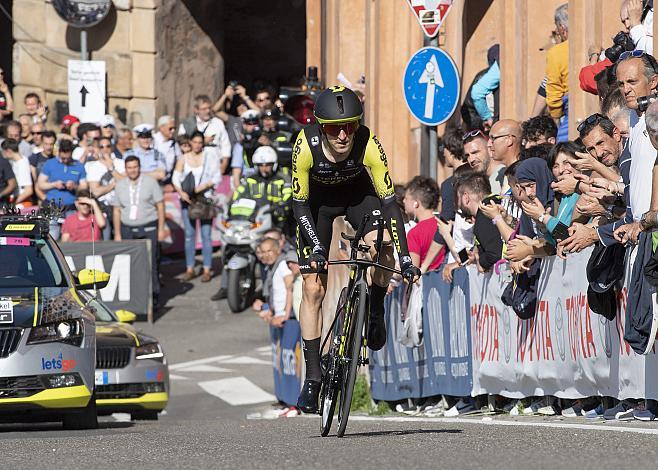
left=178, top=95, right=231, bottom=174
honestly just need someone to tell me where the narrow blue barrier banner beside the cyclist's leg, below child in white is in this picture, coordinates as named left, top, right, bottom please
left=270, top=319, right=302, bottom=406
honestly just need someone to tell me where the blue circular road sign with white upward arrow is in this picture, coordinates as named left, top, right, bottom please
left=403, top=47, right=459, bottom=126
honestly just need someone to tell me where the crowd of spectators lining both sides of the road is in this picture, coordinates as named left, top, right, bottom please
left=0, top=0, right=658, bottom=419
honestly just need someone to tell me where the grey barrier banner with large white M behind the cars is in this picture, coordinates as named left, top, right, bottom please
left=59, top=240, right=152, bottom=318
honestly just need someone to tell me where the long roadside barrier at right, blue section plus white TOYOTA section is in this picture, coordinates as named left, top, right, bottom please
left=371, top=246, right=658, bottom=401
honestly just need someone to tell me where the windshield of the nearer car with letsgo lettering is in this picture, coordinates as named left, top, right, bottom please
left=0, top=237, right=66, bottom=287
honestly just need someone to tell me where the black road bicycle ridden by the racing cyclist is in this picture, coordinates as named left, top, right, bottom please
left=320, top=210, right=402, bottom=437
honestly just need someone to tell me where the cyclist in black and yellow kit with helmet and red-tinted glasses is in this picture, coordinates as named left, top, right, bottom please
left=292, top=86, right=420, bottom=413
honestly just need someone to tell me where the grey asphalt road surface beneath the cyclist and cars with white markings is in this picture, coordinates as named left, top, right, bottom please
left=0, top=258, right=658, bottom=470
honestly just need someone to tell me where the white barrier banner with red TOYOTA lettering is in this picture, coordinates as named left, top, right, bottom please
left=468, top=249, right=658, bottom=399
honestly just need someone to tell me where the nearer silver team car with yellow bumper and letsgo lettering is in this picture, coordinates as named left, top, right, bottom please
left=0, top=213, right=109, bottom=429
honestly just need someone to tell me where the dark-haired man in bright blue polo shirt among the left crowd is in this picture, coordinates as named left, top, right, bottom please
left=37, top=140, right=88, bottom=240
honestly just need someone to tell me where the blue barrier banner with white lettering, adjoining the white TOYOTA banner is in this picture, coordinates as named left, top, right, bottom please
left=370, top=270, right=472, bottom=401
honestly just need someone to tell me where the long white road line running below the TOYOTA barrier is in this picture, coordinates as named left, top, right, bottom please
left=350, top=416, right=658, bottom=435
